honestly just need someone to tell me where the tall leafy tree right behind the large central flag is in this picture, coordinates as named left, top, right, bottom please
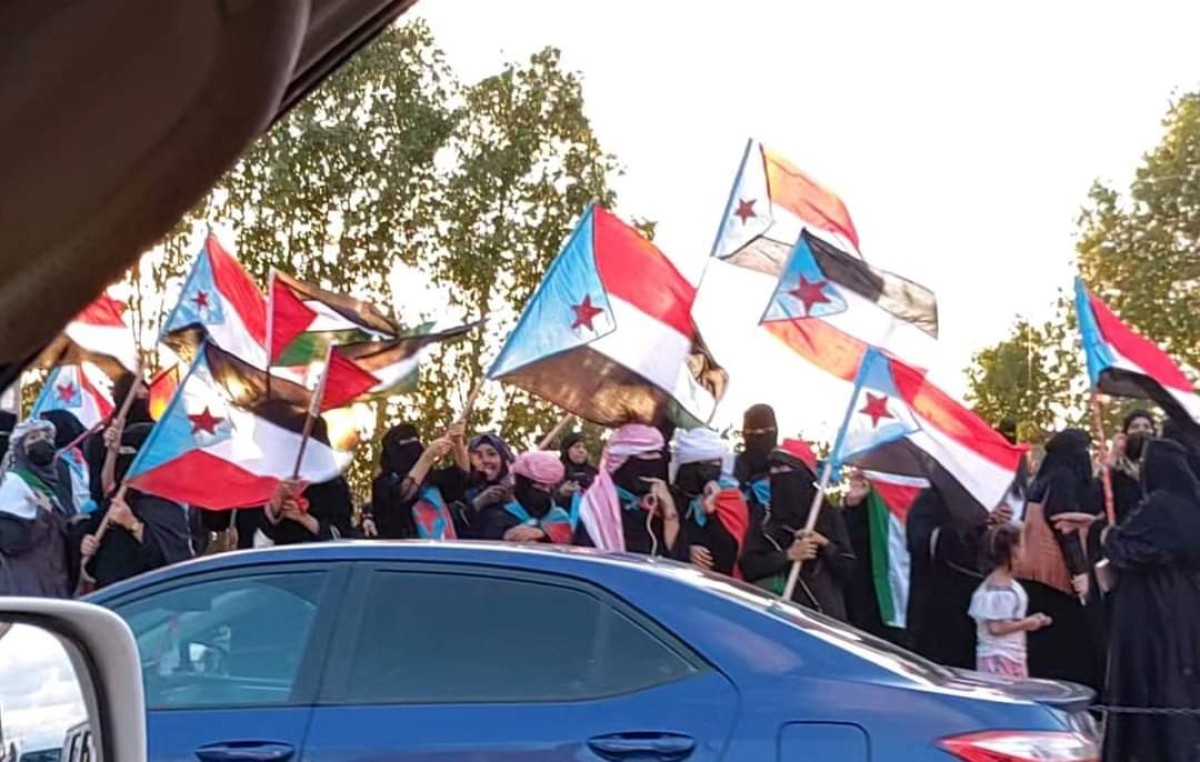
left=424, top=48, right=617, bottom=448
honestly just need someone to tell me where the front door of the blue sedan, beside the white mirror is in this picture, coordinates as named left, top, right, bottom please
left=106, top=564, right=350, bottom=762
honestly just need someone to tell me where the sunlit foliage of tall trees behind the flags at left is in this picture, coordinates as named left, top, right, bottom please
left=112, top=20, right=617, bottom=496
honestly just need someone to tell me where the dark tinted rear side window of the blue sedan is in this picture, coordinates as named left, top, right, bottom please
left=346, top=571, right=695, bottom=703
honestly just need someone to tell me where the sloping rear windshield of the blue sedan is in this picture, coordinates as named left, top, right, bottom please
left=661, top=565, right=954, bottom=684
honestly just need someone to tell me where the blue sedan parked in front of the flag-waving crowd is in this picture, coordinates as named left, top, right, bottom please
left=91, top=542, right=1097, bottom=762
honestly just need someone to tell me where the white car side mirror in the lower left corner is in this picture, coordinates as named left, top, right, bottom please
left=0, top=596, right=146, bottom=762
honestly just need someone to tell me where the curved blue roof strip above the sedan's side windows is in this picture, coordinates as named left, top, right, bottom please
left=91, top=540, right=703, bottom=600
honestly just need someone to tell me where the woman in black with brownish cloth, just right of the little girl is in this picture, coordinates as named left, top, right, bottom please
left=1014, top=428, right=1103, bottom=689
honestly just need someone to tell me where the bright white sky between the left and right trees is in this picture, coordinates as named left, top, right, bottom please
left=415, top=0, right=1200, bottom=439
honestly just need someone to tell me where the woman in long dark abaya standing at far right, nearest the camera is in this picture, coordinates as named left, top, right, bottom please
left=1060, top=439, right=1200, bottom=762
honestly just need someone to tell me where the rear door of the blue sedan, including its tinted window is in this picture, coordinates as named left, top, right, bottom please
left=304, top=564, right=738, bottom=762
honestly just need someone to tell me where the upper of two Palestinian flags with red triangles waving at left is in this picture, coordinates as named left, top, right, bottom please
left=268, top=270, right=403, bottom=367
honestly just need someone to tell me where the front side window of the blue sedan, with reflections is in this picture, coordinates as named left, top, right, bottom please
left=113, top=571, right=328, bottom=709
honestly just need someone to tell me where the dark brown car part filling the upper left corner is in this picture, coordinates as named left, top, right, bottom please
left=0, top=0, right=415, bottom=388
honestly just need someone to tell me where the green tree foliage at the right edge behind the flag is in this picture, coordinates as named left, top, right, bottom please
left=967, top=92, right=1200, bottom=442
